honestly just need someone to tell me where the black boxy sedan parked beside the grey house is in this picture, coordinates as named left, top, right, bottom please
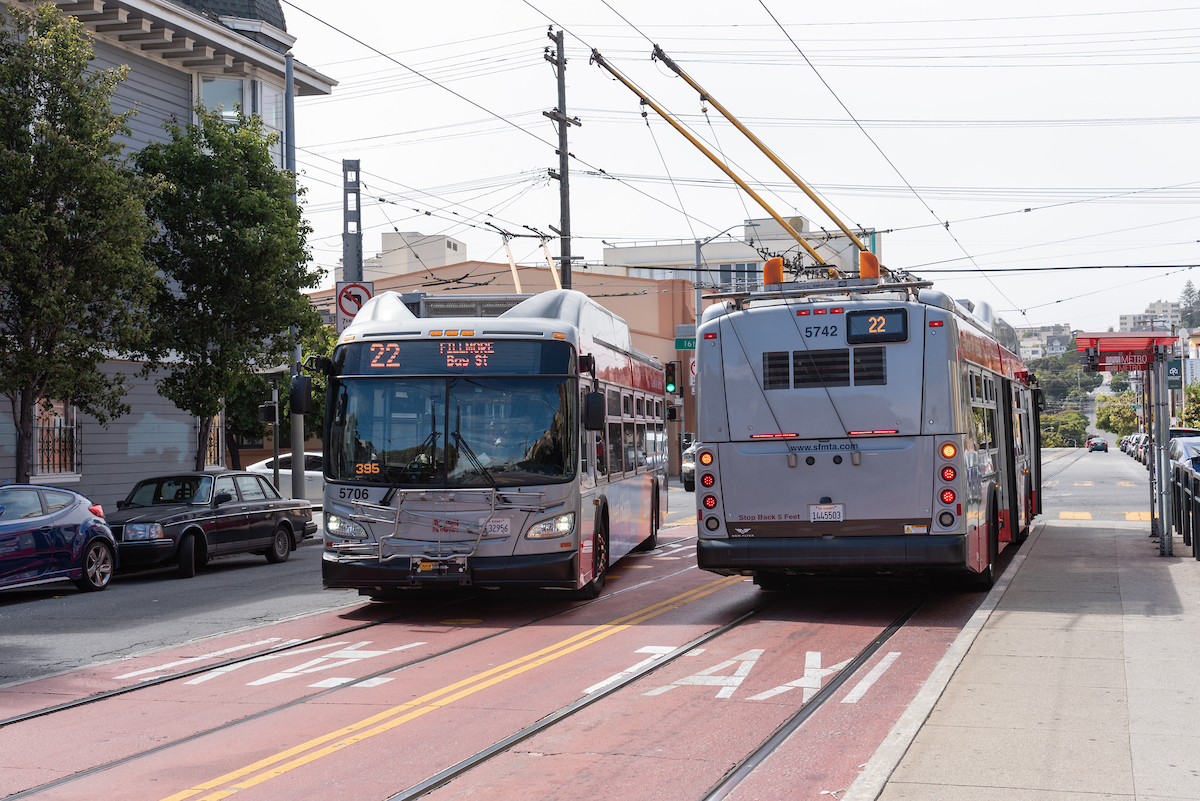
left=109, top=470, right=317, bottom=578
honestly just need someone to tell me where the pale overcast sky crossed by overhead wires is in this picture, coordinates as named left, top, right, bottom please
left=283, top=0, right=1200, bottom=331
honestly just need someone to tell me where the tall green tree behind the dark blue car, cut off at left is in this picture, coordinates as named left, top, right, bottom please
left=0, top=4, right=156, bottom=481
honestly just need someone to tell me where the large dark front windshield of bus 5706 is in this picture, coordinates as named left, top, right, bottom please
left=328, top=377, right=576, bottom=487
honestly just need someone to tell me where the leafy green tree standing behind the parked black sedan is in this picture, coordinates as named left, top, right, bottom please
left=137, top=107, right=320, bottom=469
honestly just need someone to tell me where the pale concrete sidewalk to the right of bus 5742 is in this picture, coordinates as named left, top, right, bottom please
left=842, top=520, right=1200, bottom=801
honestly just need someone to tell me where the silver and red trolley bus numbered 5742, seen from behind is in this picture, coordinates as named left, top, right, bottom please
left=696, top=278, right=1040, bottom=588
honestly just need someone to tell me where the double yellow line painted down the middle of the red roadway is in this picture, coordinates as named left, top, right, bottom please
left=163, top=576, right=742, bottom=801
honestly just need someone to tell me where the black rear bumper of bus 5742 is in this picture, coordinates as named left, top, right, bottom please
left=696, top=534, right=967, bottom=576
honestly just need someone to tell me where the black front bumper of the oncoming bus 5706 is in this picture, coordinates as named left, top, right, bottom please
left=320, top=550, right=580, bottom=590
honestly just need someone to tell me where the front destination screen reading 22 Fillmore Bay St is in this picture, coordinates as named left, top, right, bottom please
left=336, top=338, right=575, bottom=375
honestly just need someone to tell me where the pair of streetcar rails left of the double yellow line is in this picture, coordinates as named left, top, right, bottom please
left=0, top=561, right=697, bottom=801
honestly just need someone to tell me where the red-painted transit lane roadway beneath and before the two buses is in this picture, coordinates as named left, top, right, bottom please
left=0, top=529, right=982, bottom=800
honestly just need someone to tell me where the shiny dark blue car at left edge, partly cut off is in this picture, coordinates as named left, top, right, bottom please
left=0, top=484, right=116, bottom=592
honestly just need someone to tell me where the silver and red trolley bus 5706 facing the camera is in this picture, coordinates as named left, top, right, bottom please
left=320, top=290, right=667, bottom=597
